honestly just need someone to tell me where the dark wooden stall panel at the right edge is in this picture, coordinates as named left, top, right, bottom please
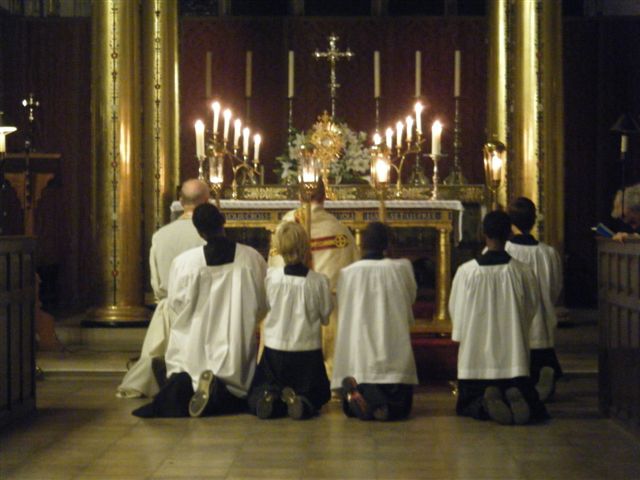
left=598, top=239, right=640, bottom=433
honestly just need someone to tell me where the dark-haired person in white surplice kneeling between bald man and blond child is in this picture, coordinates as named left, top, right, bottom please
left=134, top=204, right=267, bottom=417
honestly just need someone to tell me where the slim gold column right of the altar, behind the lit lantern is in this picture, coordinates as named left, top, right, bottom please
left=478, top=0, right=509, bottom=205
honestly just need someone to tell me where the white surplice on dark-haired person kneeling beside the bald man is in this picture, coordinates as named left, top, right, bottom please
left=165, top=244, right=267, bottom=397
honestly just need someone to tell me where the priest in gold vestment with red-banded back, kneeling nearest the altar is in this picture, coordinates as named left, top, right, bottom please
left=269, top=181, right=359, bottom=376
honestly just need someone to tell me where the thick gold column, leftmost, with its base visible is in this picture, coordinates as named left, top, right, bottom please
left=88, top=0, right=148, bottom=324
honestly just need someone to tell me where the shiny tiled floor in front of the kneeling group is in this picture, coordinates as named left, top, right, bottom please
left=0, top=312, right=640, bottom=480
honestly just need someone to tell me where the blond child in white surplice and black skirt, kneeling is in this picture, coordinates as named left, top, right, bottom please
left=248, top=222, right=333, bottom=420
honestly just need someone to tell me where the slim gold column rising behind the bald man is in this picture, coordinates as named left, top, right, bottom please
left=142, top=0, right=180, bottom=255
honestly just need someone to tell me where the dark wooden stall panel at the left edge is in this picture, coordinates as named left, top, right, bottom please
left=0, top=236, right=36, bottom=428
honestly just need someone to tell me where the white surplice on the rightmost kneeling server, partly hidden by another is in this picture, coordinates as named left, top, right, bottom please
left=505, top=242, right=562, bottom=348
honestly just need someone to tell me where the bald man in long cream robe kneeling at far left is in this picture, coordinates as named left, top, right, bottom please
left=116, top=178, right=209, bottom=398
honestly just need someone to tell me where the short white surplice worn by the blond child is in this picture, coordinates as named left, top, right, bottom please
left=263, top=267, right=333, bottom=352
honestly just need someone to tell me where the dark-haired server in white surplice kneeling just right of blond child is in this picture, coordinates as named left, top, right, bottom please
left=331, top=222, right=418, bottom=420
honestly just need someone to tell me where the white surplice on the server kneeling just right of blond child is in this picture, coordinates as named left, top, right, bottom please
left=331, top=259, right=418, bottom=389
